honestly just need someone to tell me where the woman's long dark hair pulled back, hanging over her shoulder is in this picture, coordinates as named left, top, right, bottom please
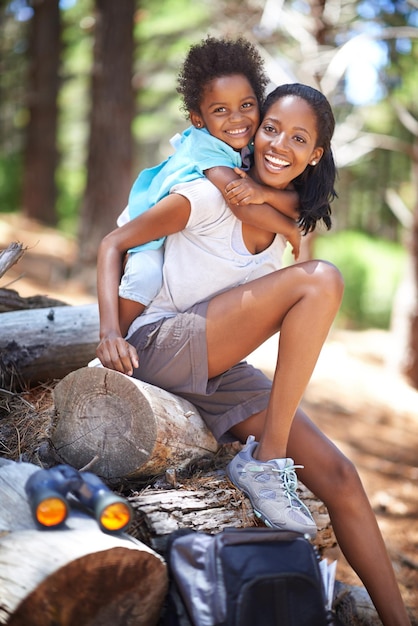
left=262, top=83, right=337, bottom=234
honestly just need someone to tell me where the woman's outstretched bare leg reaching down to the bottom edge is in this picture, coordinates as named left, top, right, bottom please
left=233, top=409, right=411, bottom=626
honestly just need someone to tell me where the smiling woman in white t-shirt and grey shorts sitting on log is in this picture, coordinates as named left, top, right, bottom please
left=97, top=84, right=410, bottom=626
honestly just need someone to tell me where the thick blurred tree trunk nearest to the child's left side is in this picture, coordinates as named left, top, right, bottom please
left=79, top=0, right=135, bottom=269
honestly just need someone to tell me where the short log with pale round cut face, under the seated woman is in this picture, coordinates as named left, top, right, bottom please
left=51, top=367, right=218, bottom=479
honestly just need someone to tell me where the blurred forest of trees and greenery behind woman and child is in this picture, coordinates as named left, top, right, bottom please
left=0, top=0, right=418, bottom=388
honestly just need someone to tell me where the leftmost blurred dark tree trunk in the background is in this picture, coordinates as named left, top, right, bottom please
left=22, top=0, right=61, bottom=226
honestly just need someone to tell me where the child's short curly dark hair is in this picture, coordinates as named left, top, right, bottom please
left=177, top=37, right=269, bottom=113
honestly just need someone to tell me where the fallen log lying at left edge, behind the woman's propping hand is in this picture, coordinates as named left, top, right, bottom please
left=0, top=304, right=99, bottom=388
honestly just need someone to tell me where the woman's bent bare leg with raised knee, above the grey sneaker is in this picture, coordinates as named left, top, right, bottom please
left=206, top=261, right=343, bottom=461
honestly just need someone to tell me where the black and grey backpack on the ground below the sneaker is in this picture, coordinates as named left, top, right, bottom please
left=163, top=527, right=336, bottom=626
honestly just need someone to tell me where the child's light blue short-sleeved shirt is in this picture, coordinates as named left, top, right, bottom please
left=128, top=126, right=247, bottom=252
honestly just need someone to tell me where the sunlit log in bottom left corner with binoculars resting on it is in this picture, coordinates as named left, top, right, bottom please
left=0, top=459, right=168, bottom=626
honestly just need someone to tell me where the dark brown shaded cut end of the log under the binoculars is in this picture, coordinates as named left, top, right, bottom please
left=7, top=548, right=168, bottom=626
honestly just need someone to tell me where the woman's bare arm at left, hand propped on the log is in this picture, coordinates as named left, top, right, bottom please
left=96, top=194, right=190, bottom=375
